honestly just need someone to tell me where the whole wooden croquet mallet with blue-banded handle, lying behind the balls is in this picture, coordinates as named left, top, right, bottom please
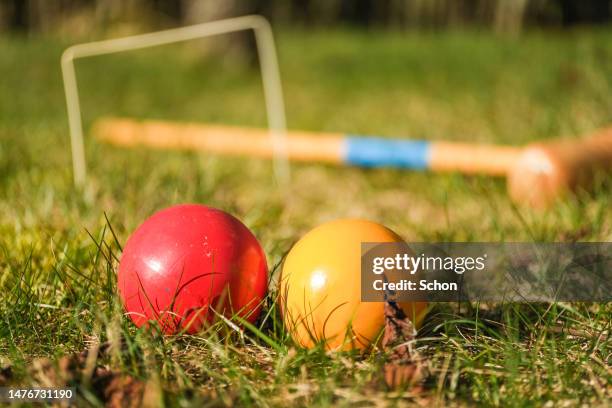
left=93, top=118, right=612, bottom=208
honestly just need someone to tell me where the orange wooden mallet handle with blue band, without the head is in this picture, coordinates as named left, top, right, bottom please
left=93, top=118, right=521, bottom=176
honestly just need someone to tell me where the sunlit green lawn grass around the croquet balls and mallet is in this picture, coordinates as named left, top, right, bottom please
left=0, top=25, right=612, bottom=406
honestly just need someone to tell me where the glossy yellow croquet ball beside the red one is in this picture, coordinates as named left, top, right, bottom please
left=280, top=219, right=427, bottom=350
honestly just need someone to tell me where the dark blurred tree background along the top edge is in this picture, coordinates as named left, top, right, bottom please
left=0, top=0, right=612, bottom=35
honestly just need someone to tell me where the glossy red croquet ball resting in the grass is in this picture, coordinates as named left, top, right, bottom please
left=118, top=204, right=268, bottom=334
